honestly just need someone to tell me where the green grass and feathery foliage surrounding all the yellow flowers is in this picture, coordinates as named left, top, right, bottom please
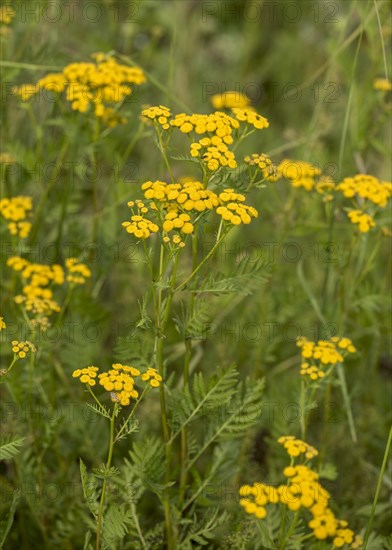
left=0, top=0, right=392, bottom=550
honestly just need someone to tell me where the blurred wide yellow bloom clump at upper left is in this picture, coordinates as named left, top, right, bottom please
left=14, top=53, right=146, bottom=127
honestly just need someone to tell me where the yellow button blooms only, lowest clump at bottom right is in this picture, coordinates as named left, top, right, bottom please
left=239, top=436, right=363, bottom=549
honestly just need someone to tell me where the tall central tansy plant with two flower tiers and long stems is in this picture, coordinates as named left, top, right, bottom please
left=116, top=101, right=269, bottom=548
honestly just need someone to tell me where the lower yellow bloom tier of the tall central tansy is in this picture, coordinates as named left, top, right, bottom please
left=122, top=179, right=258, bottom=247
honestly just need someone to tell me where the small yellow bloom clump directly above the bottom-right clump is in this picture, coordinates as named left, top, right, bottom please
left=297, top=336, right=356, bottom=380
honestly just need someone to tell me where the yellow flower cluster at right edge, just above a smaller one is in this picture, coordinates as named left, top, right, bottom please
left=336, top=174, right=392, bottom=208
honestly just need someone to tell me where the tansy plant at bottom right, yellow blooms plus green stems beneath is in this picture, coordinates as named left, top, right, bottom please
left=239, top=436, right=363, bottom=550
